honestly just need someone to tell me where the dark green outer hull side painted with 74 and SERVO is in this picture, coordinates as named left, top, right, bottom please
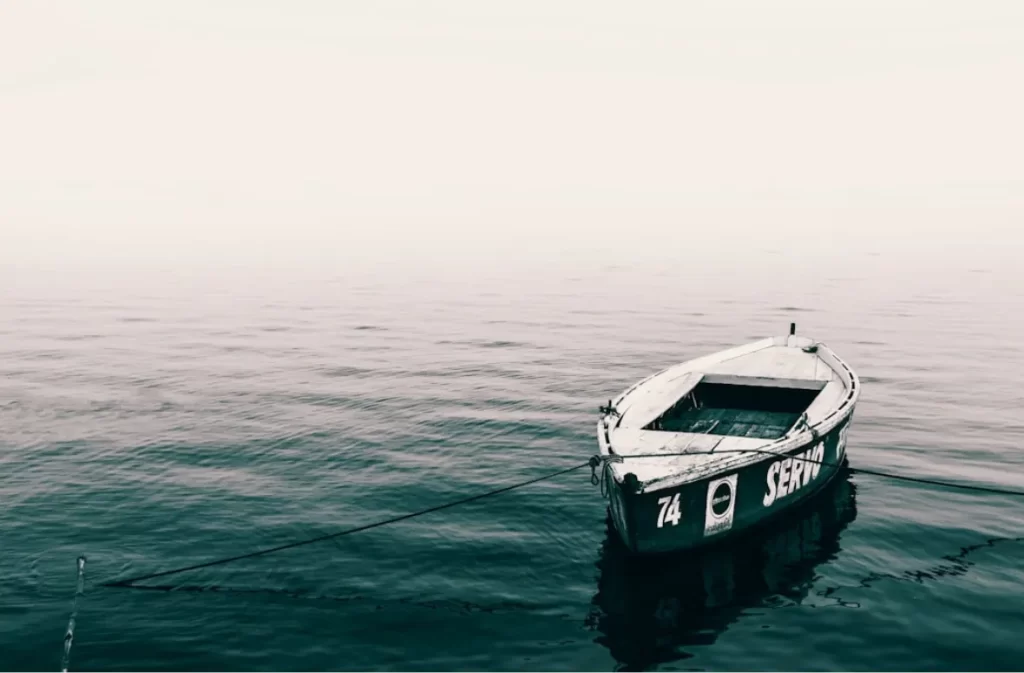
left=607, top=410, right=853, bottom=554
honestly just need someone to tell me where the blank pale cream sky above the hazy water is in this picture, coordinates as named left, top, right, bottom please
left=0, top=0, right=1024, bottom=266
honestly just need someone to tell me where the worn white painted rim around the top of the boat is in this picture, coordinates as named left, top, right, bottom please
left=597, top=335, right=860, bottom=492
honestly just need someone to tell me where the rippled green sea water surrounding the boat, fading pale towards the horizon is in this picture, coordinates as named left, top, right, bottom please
left=0, top=257, right=1024, bottom=670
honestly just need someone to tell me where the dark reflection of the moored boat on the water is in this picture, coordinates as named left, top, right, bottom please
left=588, top=469, right=857, bottom=670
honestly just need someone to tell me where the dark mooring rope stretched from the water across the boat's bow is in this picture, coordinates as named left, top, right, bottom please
left=99, top=449, right=1024, bottom=589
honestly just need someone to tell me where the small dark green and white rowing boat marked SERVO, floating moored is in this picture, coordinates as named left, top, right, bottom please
left=592, top=324, right=860, bottom=554
